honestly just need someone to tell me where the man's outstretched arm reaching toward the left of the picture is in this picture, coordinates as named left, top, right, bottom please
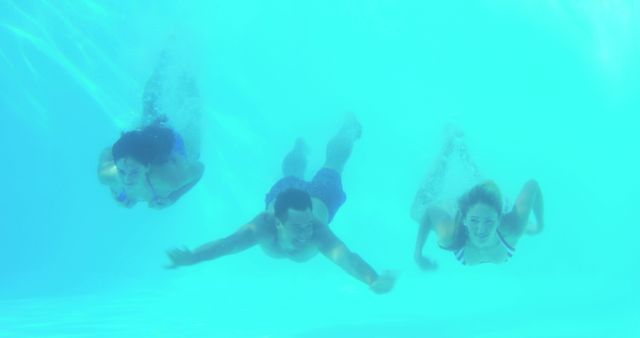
left=167, top=214, right=265, bottom=269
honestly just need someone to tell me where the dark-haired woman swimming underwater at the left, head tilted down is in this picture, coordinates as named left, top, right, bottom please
left=98, top=53, right=204, bottom=209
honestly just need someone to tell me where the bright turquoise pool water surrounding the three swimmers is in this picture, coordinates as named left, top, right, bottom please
left=0, top=0, right=640, bottom=338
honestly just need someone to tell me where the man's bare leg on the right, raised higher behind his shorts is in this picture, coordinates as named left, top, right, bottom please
left=324, top=114, right=362, bottom=174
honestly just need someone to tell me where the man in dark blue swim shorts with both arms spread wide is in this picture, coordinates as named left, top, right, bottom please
left=168, top=116, right=395, bottom=293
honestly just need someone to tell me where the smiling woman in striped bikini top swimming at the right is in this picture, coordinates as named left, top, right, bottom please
left=411, top=125, right=544, bottom=270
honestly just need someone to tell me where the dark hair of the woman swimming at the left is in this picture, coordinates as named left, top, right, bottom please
left=111, top=125, right=176, bottom=165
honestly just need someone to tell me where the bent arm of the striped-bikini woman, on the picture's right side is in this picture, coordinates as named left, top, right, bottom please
left=500, top=180, right=544, bottom=238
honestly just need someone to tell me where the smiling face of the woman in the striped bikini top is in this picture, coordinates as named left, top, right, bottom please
left=463, top=203, right=500, bottom=248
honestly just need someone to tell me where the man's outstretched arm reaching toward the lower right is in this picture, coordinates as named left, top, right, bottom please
left=318, top=227, right=395, bottom=293
